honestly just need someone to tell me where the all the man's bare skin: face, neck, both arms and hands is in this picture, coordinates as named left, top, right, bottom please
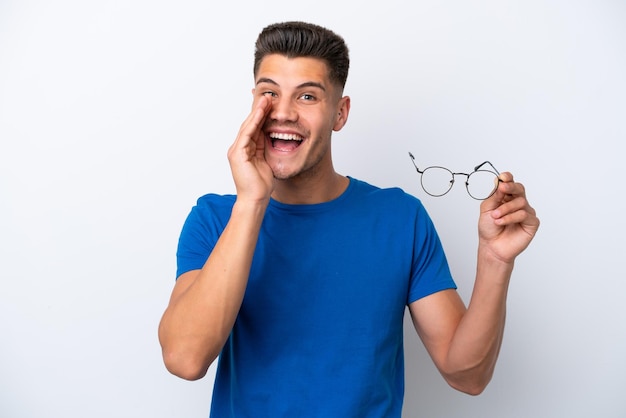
left=159, top=55, right=539, bottom=394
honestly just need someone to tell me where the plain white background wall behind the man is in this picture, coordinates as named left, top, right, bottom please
left=0, top=0, right=626, bottom=418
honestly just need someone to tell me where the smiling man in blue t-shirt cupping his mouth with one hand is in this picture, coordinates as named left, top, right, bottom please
left=159, top=22, right=539, bottom=418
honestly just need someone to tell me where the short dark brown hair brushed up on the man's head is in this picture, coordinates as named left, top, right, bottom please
left=254, top=22, right=350, bottom=92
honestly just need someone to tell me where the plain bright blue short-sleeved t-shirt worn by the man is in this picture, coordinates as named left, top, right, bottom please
left=177, top=178, right=455, bottom=418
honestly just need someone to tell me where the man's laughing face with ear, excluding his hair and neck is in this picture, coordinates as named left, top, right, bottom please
left=253, top=54, right=349, bottom=180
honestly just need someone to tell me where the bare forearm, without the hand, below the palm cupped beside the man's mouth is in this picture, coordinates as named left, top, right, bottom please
left=159, top=203, right=266, bottom=379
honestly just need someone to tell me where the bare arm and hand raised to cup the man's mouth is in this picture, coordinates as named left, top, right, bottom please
left=159, top=98, right=273, bottom=380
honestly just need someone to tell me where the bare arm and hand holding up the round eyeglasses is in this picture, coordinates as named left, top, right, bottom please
left=409, top=173, right=539, bottom=395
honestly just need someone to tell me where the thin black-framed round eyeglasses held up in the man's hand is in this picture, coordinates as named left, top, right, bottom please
left=409, top=152, right=502, bottom=200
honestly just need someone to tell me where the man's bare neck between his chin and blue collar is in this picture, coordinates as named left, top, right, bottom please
left=272, top=171, right=350, bottom=205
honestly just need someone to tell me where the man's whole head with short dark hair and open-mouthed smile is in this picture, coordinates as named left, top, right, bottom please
left=253, top=22, right=350, bottom=184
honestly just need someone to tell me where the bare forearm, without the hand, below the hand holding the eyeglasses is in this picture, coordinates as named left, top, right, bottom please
left=446, top=250, right=513, bottom=394
